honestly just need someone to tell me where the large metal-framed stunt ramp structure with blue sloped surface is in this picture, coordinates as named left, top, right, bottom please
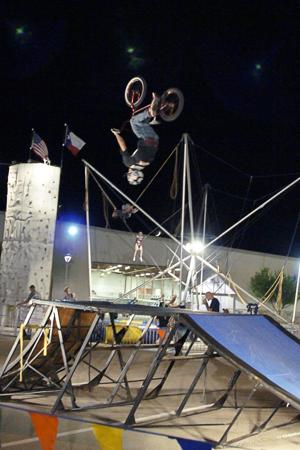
left=0, top=300, right=300, bottom=446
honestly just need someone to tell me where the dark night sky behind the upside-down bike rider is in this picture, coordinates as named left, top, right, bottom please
left=0, top=0, right=300, bottom=256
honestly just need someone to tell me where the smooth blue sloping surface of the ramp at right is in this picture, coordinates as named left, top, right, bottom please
left=185, top=313, right=300, bottom=409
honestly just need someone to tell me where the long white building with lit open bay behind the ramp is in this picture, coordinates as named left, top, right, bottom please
left=0, top=212, right=298, bottom=308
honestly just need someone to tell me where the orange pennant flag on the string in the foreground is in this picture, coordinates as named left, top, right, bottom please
left=29, top=413, right=58, bottom=450
